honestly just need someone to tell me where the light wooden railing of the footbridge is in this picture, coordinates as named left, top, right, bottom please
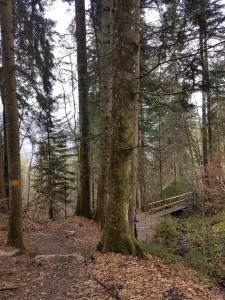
left=148, top=192, right=192, bottom=214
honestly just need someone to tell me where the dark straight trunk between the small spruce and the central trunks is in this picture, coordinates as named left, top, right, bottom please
left=75, top=0, right=91, bottom=218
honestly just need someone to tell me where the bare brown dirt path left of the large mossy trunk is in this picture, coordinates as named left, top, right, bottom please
left=0, top=214, right=109, bottom=300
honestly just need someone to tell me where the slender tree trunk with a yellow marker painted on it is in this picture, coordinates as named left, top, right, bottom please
left=0, top=0, right=24, bottom=248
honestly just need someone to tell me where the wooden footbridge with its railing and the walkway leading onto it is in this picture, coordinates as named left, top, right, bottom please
left=137, top=192, right=193, bottom=240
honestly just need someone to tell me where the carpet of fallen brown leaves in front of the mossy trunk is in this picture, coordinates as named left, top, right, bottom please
left=91, top=253, right=225, bottom=300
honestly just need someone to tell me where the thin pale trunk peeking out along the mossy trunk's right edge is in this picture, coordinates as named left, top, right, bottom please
left=128, top=0, right=140, bottom=234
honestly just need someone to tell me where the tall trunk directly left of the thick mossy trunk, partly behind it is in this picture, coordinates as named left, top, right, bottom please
left=95, top=0, right=113, bottom=228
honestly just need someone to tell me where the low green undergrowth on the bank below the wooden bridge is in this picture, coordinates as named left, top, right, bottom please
left=142, top=210, right=225, bottom=280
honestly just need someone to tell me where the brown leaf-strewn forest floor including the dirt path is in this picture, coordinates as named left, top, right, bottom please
left=0, top=215, right=225, bottom=300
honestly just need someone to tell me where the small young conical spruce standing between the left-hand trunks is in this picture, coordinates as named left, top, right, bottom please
left=33, top=128, right=75, bottom=219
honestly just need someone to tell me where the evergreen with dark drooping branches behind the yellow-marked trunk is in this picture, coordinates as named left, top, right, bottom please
left=1, top=0, right=54, bottom=203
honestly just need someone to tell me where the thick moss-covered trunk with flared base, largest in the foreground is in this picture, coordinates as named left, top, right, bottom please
left=99, top=0, right=144, bottom=257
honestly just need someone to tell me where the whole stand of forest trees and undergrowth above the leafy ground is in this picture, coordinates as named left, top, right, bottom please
left=0, top=0, right=225, bottom=288
